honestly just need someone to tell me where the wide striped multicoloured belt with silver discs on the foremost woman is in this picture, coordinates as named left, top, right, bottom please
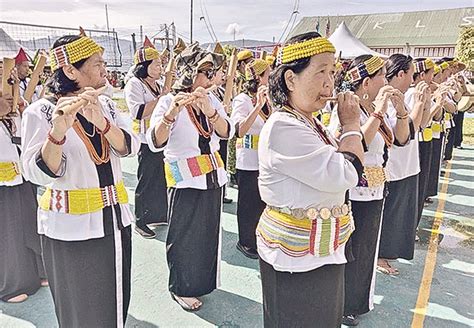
left=256, top=204, right=354, bottom=257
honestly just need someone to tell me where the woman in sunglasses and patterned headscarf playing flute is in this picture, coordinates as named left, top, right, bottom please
left=147, top=43, right=234, bottom=311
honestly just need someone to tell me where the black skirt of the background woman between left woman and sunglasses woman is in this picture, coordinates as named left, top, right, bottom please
left=135, top=144, right=168, bottom=224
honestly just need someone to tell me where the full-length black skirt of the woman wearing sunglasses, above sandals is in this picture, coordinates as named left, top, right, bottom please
left=166, top=188, right=222, bottom=297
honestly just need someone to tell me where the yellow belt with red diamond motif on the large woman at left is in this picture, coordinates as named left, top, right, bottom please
left=39, top=181, right=128, bottom=215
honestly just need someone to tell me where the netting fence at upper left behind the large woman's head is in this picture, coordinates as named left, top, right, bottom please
left=0, top=21, right=122, bottom=67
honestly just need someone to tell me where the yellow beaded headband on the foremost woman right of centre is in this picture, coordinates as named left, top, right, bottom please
left=277, top=37, right=336, bottom=65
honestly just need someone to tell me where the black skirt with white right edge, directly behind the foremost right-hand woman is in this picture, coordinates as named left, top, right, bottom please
left=344, top=200, right=384, bottom=315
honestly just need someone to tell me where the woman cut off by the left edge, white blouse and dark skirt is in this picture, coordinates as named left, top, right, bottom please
left=0, top=86, right=47, bottom=303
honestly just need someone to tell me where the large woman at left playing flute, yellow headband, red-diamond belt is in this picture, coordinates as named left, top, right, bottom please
left=22, top=35, right=140, bottom=327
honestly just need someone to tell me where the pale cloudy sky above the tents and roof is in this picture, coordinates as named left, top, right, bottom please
left=0, top=0, right=474, bottom=42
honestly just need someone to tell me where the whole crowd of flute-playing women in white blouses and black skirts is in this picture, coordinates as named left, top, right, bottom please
left=0, top=27, right=467, bottom=327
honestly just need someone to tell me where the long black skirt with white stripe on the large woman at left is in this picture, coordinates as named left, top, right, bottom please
left=41, top=227, right=132, bottom=328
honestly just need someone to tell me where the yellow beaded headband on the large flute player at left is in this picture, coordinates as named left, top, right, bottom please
left=50, top=36, right=104, bottom=72
